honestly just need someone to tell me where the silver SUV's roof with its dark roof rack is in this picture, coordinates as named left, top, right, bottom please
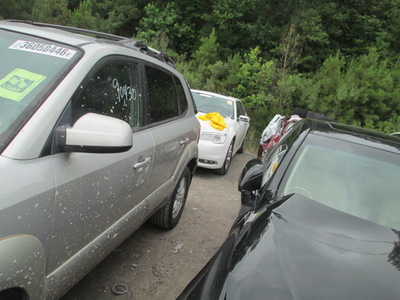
left=0, top=20, right=175, bottom=67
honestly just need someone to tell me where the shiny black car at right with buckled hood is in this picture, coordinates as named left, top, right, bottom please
left=178, top=120, right=400, bottom=300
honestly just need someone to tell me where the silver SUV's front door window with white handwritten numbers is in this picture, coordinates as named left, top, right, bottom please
left=72, top=60, right=142, bottom=127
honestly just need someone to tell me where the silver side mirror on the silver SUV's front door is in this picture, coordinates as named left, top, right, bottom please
left=57, top=113, right=133, bottom=153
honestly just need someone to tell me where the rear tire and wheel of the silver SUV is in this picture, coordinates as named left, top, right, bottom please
left=150, top=168, right=190, bottom=229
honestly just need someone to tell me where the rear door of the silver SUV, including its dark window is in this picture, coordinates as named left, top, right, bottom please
left=145, top=65, right=196, bottom=212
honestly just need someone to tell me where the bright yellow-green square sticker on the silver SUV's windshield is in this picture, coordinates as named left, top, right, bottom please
left=0, top=68, right=46, bottom=102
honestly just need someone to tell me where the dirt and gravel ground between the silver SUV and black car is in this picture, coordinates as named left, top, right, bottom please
left=62, top=153, right=255, bottom=300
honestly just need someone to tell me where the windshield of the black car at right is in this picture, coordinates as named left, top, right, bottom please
left=283, top=137, right=400, bottom=230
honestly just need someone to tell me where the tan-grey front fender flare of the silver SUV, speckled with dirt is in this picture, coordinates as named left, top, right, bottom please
left=0, top=235, right=46, bottom=299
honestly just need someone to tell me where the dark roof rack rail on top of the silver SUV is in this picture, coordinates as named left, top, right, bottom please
left=5, top=20, right=175, bottom=68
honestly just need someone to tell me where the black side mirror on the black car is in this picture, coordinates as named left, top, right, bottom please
left=238, top=159, right=265, bottom=206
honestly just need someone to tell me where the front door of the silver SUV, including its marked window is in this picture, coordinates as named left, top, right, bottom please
left=48, top=57, right=154, bottom=272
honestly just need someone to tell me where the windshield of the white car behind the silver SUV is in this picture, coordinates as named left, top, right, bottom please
left=192, top=92, right=235, bottom=119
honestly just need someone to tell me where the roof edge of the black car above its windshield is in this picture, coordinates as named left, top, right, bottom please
left=299, top=119, right=400, bottom=154
